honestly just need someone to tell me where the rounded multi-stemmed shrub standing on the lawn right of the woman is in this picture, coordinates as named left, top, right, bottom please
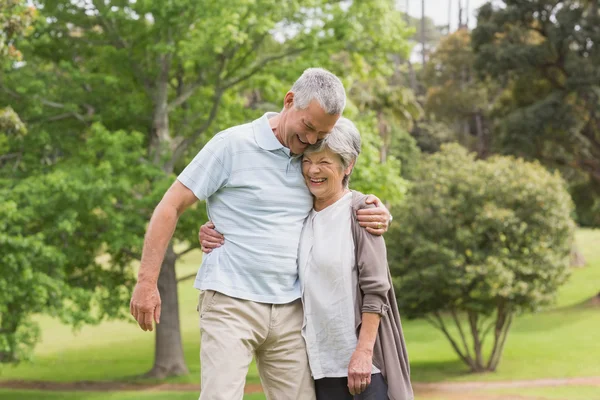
left=386, top=144, right=574, bottom=372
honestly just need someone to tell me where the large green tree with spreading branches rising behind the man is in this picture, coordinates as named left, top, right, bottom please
left=1, top=0, right=412, bottom=377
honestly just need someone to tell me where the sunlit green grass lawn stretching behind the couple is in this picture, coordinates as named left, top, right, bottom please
left=0, top=229, right=600, bottom=399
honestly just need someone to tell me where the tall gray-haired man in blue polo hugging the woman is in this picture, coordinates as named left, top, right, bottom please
left=131, top=68, right=389, bottom=400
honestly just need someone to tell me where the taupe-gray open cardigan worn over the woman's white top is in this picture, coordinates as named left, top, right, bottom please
left=352, top=191, right=414, bottom=400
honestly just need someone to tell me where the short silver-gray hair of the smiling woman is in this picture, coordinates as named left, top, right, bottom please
left=304, top=117, right=361, bottom=187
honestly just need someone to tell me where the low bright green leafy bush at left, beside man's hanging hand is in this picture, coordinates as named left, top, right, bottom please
left=0, top=125, right=162, bottom=362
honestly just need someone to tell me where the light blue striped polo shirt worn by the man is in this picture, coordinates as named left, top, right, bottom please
left=177, top=113, right=313, bottom=304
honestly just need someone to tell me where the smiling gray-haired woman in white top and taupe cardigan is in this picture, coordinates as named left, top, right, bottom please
left=298, top=117, right=413, bottom=400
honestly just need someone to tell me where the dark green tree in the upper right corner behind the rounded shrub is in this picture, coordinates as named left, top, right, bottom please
left=472, top=0, right=600, bottom=226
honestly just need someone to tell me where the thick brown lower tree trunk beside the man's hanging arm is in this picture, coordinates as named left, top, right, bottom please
left=146, top=244, right=189, bottom=379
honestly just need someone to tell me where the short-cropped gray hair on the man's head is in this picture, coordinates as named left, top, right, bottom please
left=290, top=68, right=346, bottom=115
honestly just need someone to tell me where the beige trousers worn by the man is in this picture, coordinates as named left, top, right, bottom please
left=198, top=290, right=316, bottom=400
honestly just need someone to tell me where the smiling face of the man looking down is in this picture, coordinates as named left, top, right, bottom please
left=278, top=92, right=340, bottom=154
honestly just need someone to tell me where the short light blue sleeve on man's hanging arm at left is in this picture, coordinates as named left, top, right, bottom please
left=177, top=132, right=232, bottom=200
